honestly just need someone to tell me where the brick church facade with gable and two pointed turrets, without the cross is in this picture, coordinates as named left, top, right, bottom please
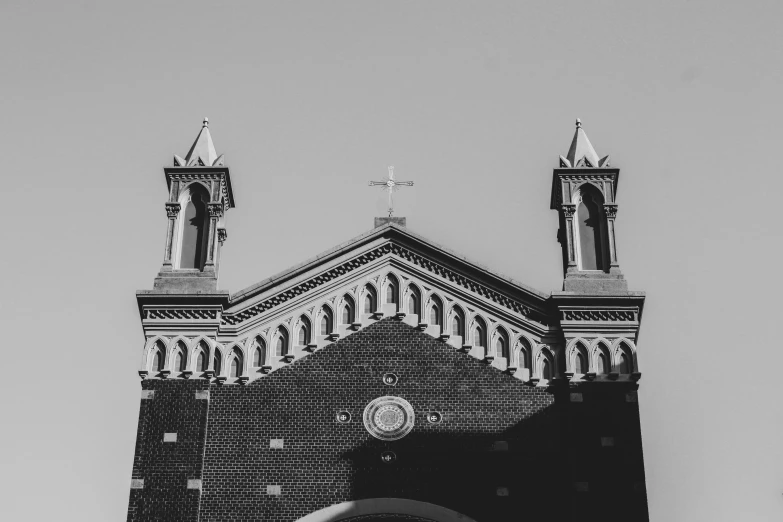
left=128, top=120, right=648, bottom=522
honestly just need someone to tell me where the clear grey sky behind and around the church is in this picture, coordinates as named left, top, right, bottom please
left=0, top=0, right=783, bottom=522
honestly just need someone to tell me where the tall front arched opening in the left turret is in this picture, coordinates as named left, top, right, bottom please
left=176, top=183, right=209, bottom=270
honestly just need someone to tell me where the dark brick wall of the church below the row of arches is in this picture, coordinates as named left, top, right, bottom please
left=128, top=319, right=647, bottom=522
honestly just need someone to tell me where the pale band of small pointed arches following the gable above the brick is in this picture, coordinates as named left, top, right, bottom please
left=139, top=266, right=636, bottom=384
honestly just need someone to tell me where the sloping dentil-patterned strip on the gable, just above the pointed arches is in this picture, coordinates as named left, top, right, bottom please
left=221, top=244, right=546, bottom=325
